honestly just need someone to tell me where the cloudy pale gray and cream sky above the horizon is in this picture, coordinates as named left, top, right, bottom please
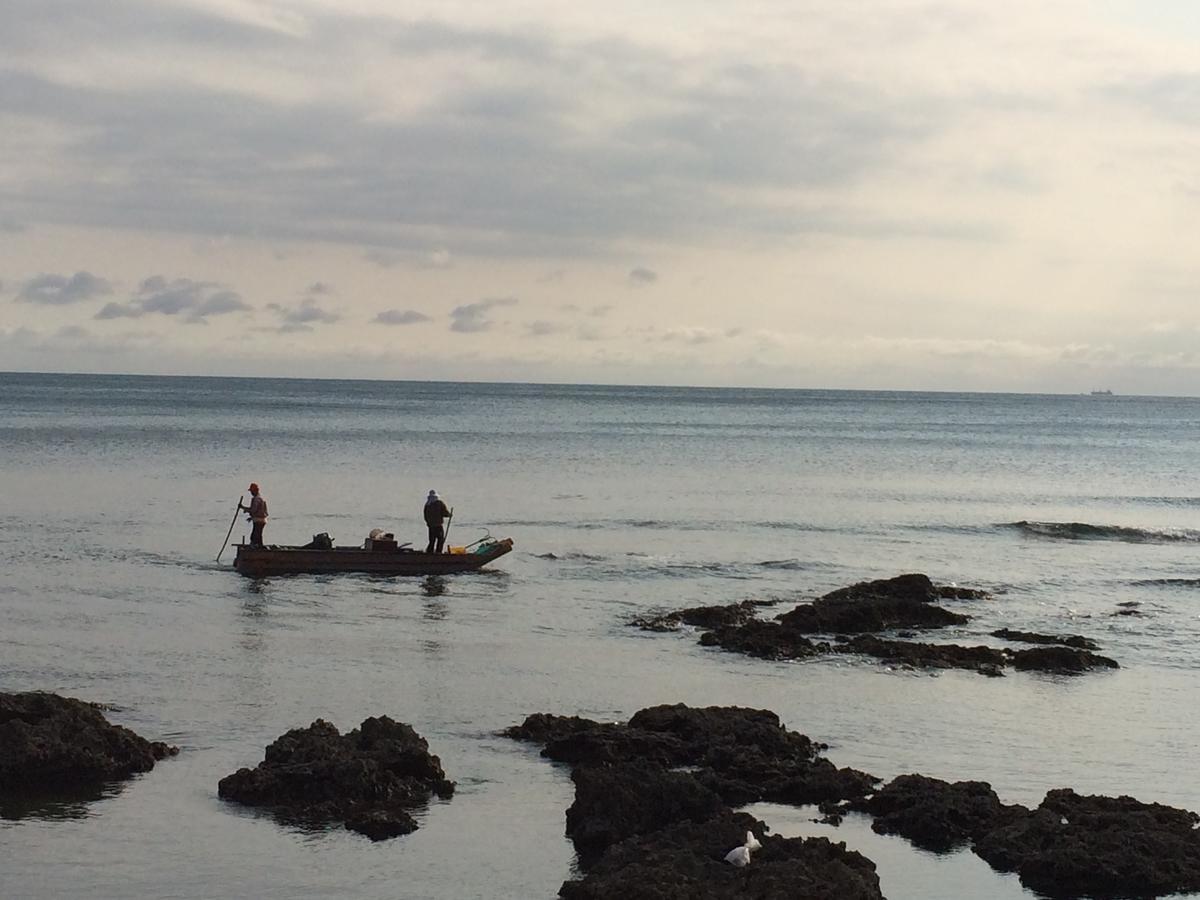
left=0, top=0, right=1200, bottom=396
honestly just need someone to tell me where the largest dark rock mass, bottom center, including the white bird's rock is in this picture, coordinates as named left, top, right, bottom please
left=502, top=703, right=882, bottom=900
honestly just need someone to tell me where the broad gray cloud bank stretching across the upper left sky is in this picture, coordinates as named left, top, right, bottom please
left=0, top=0, right=978, bottom=258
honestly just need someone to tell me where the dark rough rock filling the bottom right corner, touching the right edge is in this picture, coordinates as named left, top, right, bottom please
left=974, top=790, right=1200, bottom=898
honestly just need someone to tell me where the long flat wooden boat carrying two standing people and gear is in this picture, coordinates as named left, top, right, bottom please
left=233, top=538, right=512, bottom=578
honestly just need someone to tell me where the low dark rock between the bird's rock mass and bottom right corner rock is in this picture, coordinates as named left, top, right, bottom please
left=850, top=775, right=1028, bottom=853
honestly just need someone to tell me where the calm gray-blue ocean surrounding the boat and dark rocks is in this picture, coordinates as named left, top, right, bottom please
left=0, top=373, right=1200, bottom=900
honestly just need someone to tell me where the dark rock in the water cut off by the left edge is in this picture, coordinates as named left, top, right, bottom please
left=0, top=691, right=179, bottom=794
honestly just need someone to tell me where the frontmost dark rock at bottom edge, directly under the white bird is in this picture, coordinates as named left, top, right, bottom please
left=559, top=811, right=883, bottom=900
